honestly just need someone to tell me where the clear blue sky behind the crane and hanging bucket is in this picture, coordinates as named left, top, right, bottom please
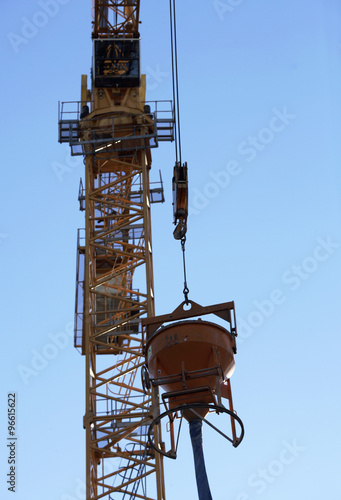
left=0, top=0, right=341, bottom=500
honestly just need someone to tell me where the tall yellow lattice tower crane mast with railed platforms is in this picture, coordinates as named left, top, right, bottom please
left=59, top=0, right=174, bottom=500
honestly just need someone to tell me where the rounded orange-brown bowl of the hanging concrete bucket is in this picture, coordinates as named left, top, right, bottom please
left=146, top=319, right=235, bottom=414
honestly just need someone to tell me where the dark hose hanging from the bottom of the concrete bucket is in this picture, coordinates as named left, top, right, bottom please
left=189, top=419, right=212, bottom=500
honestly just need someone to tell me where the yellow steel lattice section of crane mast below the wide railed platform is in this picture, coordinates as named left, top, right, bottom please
left=81, top=149, right=162, bottom=498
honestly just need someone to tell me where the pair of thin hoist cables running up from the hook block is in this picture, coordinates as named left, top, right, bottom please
left=169, top=0, right=181, bottom=165
